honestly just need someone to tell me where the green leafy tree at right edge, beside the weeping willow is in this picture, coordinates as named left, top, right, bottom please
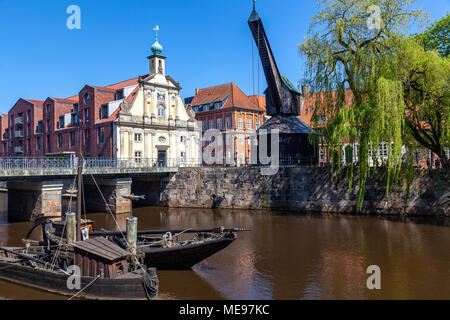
left=379, top=38, right=450, bottom=166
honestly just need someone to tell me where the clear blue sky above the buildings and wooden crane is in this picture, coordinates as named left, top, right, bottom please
left=0, top=0, right=450, bottom=113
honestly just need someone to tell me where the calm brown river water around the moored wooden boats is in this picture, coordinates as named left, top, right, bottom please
left=0, top=194, right=450, bottom=300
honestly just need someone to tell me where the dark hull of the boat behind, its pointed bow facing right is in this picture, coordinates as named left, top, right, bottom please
left=142, top=234, right=236, bottom=270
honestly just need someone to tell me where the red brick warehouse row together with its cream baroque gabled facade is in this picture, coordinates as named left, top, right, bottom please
left=0, top=34, right=200, bottom=166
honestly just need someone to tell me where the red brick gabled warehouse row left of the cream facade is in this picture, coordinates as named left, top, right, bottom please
left=0, top=76, right=145, bottom=158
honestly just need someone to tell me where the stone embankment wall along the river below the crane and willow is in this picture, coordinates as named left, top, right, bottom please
left=160, top=167, right=450, bottom=217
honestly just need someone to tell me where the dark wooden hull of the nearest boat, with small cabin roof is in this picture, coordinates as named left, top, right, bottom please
left=0, top=260, right=147, bottom=300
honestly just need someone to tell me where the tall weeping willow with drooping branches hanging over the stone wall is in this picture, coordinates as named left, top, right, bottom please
left=299, top=0, right=426, bottom=209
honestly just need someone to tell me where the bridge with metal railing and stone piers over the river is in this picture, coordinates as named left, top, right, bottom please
left=0, top=159, right=183, bottom=221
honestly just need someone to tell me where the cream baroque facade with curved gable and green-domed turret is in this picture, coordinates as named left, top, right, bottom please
left=113, top=34, right=201, bottom=166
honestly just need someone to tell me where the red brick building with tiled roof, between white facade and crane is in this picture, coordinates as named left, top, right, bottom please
left=189, top=82, right=265, bottom=163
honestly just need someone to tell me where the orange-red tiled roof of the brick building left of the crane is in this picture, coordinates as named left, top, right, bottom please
left=191, top=82, right=265, bottom=112
